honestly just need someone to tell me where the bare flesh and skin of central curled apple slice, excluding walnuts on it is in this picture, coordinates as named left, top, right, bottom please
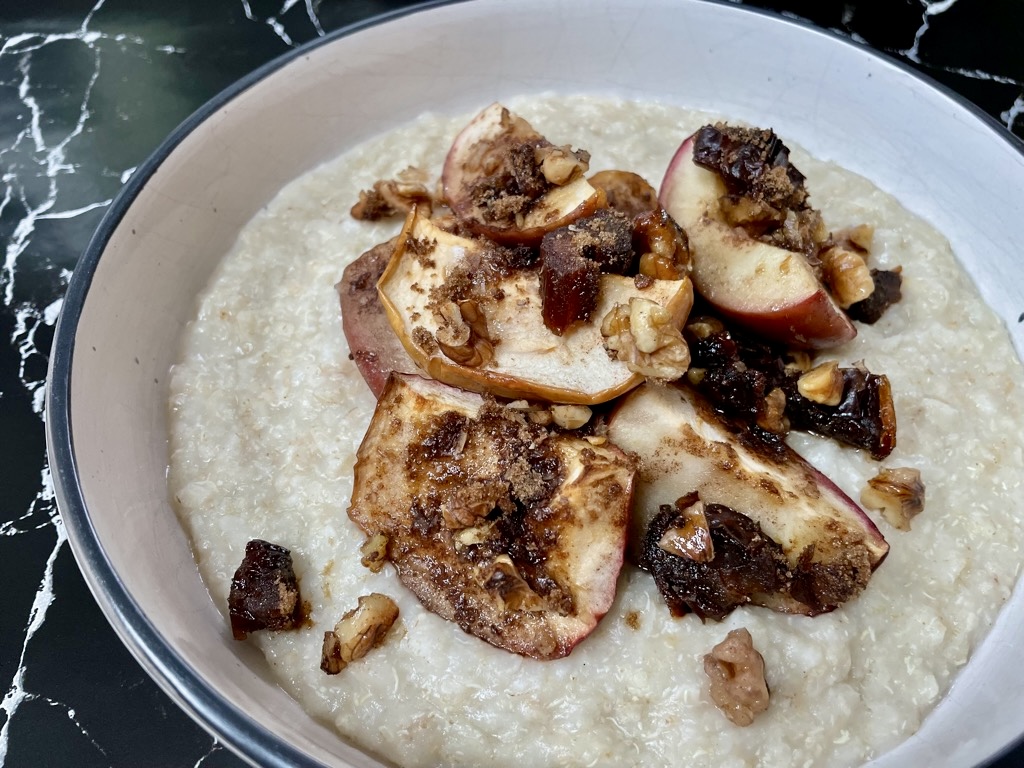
left=378, top=211, right=693, bottom=404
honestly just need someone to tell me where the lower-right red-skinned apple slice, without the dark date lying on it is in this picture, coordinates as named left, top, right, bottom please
left=608, top=384, right=889, bottom=615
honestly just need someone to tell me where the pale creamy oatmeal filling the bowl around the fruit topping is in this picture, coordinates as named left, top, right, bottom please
left=169, top=97, right=1024, bottom=766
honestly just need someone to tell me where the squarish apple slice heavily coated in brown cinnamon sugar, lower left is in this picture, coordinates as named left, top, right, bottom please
left=348, top=374, right=635, bottom=659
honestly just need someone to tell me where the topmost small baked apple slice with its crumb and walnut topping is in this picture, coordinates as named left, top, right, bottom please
left=441, top=103, right=601, bottom=245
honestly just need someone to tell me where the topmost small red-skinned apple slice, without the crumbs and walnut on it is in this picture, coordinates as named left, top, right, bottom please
left=441, top=103, right=602, bottom=245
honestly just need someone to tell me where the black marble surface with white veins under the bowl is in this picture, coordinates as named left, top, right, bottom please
left=0, top=0, right=1024, bottom=768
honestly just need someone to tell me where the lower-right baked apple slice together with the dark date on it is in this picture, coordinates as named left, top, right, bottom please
left=608, top=385, right=889, bottom=618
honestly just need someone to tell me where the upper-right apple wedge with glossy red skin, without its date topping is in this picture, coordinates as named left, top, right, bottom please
left=658, top=134, right=857, bottom=349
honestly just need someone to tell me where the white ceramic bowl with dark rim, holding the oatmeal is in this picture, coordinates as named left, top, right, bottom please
left=47, top=0, right=1024, bottom=767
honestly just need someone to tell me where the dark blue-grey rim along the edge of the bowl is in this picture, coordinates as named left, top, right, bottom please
left=45, top=0, right=1024, bottom=768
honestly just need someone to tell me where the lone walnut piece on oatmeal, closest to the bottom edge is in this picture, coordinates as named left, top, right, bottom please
left=703, top=629, right=769, bottom=726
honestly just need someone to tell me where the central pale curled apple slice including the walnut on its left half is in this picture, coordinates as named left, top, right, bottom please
left=378, top=211, right=693, bottom=404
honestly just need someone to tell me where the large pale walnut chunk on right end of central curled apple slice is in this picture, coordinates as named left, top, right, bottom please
left=601, top=297, right=690, bottom=381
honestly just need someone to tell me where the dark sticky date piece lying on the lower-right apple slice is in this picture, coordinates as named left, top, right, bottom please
left=640, top=500, right=786, bottom=620
